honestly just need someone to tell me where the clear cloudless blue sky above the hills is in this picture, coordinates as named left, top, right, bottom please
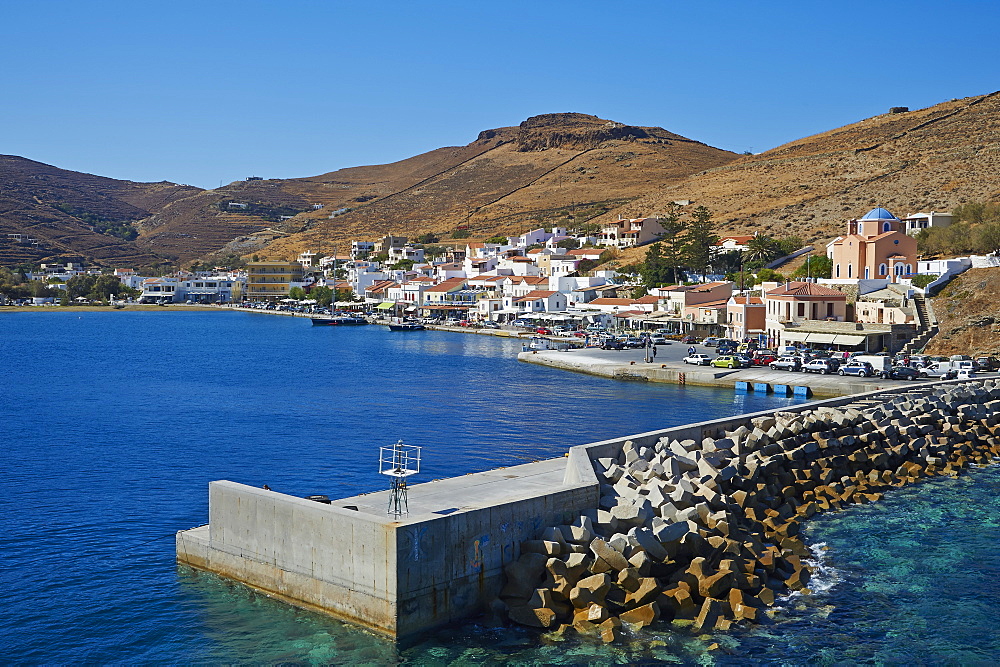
left=0, top=0, right=1000, bottom=187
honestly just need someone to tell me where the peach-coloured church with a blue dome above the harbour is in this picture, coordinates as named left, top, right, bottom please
left=831, top=207, right=917, bottom=282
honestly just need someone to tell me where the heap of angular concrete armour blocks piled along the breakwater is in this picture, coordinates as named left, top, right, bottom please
left=494, top=380, right=1000, bottom=641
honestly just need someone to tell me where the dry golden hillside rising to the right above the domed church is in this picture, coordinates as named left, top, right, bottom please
left=592, top=93, right=1000, bottom=241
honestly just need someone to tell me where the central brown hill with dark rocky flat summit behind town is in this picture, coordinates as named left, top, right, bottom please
left=261, top=114, right=735, bottom=257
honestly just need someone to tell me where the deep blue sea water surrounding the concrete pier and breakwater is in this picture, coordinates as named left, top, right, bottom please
left=0, top=312, right=1000, bottom=665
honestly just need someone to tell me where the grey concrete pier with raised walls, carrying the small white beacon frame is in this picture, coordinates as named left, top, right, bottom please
left=176, top=382, right=976, bottom=639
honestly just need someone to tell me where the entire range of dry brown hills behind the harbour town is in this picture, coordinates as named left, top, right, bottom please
left=0, top=93, right=1000, bottom=265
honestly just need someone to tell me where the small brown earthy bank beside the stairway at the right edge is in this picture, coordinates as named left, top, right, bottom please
left=926, top=269, right=1000, bottom=356
